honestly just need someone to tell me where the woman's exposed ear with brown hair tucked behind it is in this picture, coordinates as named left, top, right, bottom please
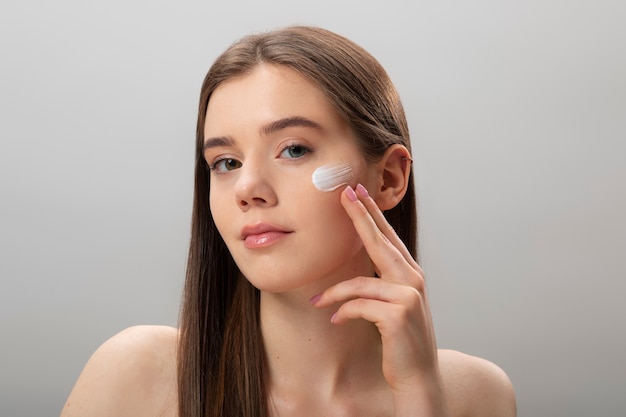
left=375, top=144, right=412, bottom=211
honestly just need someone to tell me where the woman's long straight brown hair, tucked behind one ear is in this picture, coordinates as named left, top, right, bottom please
left=178, top=26, right=417, bottom=417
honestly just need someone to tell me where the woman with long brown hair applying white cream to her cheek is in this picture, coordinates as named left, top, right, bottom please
left=62, top=27, right=515, bottom=417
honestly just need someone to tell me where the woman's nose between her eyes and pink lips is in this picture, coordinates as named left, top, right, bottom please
left=235, top=161, right=278, bottom=211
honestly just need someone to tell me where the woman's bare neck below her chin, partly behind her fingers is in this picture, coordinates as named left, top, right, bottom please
left=261, top=286, right=382, bottom=398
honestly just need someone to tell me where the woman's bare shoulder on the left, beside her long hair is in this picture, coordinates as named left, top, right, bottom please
left=61, top=326, right=178, bottom=417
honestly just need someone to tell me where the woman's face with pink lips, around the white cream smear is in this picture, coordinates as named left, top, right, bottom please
left=204, top=65, right=376, bottom=295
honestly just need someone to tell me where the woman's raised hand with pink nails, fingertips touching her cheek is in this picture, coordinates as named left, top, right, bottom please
left=314, top=184, right=447, bottom=416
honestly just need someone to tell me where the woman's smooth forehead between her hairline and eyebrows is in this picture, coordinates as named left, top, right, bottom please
left=204, top=64, right=347, bottom=137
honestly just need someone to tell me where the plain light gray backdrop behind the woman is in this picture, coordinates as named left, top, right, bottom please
left=0, top=0, right=626, bottom=417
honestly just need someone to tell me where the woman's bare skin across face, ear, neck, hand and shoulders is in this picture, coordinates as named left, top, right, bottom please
left=61, top=65, right=516, bottom=417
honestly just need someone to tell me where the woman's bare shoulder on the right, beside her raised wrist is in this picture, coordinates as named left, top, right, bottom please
left=439, top=349, right=517, bottom=417
